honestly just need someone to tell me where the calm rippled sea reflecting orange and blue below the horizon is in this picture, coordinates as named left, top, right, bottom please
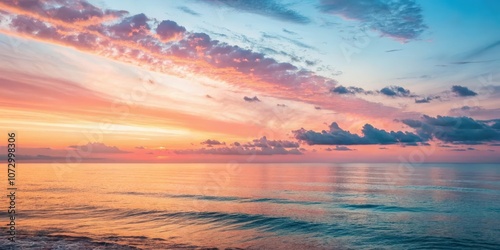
left=0, top=164, right=500, bottom=249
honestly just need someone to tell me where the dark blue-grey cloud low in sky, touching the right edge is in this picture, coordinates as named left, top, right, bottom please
left=402, top=115, right=500, bottom=144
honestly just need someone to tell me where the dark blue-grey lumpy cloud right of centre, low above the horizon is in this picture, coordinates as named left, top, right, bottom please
left=293, top=122, right=425, bottom=145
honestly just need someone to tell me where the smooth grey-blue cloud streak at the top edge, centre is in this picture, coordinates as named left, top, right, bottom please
left=198, top=0, right=311, bottom=24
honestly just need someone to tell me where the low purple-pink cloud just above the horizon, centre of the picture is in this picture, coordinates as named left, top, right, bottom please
left=174, top=136, right=302, bottom=155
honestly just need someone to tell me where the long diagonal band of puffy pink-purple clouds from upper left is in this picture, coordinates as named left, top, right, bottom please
left=0, top=0, right=415, bottom=121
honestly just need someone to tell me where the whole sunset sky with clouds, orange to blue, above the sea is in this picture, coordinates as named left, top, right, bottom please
left=0, top=0, right=500, bottom=164
